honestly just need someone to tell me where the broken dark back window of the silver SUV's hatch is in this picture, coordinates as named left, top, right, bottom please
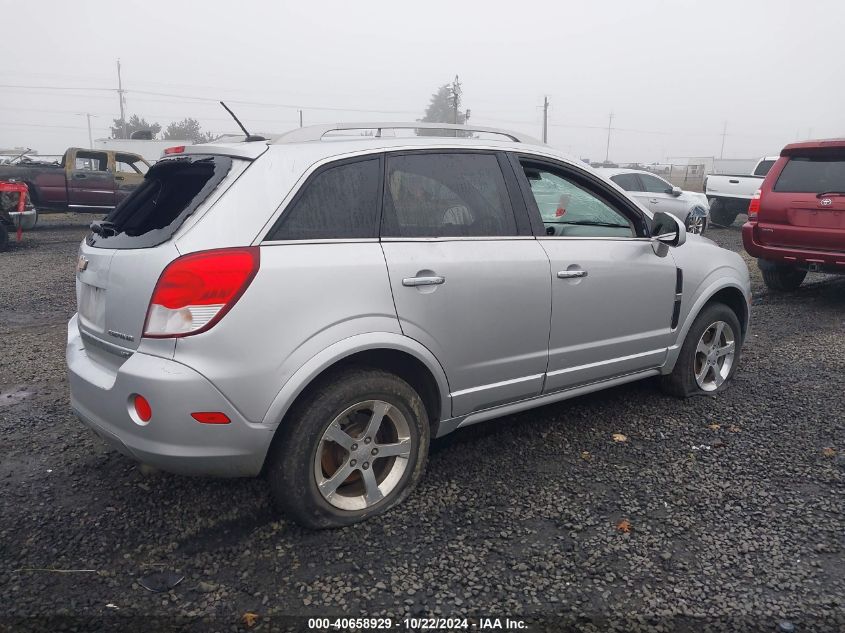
left=88, top=155, right=232, bottom=248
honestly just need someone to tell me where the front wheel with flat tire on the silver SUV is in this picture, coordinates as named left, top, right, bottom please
left=661, top=303, right=742, bottom=398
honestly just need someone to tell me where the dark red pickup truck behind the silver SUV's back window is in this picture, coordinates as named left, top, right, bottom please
left=0, top=147, right=150, bottom=226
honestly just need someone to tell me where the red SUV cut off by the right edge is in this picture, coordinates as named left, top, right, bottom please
left=742, top=139, right=845, bottom=290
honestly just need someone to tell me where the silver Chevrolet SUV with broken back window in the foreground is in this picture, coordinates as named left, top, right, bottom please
left=67, top=123, right=750, bottom=528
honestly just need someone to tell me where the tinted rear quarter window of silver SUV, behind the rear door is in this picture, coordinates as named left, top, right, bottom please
left=266, top=158, right=381, bottom=240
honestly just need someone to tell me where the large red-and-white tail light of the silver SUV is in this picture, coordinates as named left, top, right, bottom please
left=144, top=246, right=261, bottom=338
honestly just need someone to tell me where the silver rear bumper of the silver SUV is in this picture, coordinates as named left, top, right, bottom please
left=66, top=315, right=273, bottom=477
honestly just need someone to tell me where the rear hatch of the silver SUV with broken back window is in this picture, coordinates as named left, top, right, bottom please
left=76, top=154, right=237, bottom=366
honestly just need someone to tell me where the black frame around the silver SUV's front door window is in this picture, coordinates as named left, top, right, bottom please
left=514, top=154, right=649, bottom=239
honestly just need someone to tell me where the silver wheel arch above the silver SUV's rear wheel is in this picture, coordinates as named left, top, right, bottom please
left=263, top=332, right=451, bottom=466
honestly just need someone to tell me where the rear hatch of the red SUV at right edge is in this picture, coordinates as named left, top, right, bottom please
left=757, top=147, right=845, bottom=252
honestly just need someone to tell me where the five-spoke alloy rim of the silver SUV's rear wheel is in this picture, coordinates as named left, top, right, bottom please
left=314, top=400, right=412, bottom=510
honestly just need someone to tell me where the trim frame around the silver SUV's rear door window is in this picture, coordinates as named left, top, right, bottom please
left=378, top=148, right=532, bottom=242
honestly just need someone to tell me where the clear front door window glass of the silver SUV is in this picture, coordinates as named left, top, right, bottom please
left=524, top=165, right=636, bottom=237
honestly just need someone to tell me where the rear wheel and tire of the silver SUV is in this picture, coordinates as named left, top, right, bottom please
left=267, top=367, right=429, bottom=529
